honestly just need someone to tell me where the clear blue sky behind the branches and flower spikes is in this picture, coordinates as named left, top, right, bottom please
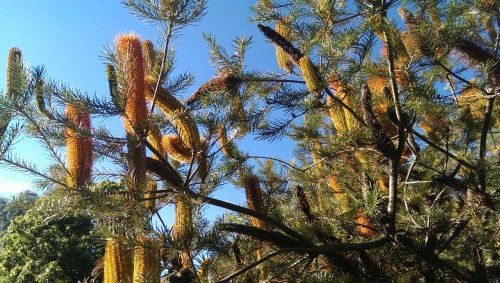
left=0, top=0, right=290, bottom=224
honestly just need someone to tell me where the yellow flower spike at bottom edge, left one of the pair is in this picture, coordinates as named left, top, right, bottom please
left=103, top=239, right=134, bottom=283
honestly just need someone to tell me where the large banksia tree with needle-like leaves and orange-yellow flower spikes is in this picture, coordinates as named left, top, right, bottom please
left=0, top=0, right=500, bottom=282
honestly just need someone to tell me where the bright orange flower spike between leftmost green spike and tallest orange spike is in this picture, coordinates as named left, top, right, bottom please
left=66, top=104, right=92, bottom=190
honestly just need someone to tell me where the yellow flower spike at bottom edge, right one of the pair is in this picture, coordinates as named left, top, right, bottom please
left=133, top=236, right=161, bottom=283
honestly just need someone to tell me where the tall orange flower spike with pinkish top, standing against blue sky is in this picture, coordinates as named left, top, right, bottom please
left=116, top=33, right=147, bottom=134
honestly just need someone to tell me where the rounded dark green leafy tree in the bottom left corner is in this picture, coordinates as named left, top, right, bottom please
left=0, top=193, right=102, bottom=283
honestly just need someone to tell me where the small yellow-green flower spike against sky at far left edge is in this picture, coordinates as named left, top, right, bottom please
left=6, top=47, right=24, bottom=99
